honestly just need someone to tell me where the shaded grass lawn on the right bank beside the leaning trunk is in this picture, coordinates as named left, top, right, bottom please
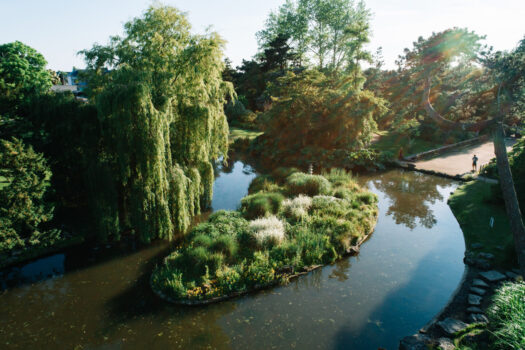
left=449, top=181, right=517, bottom=268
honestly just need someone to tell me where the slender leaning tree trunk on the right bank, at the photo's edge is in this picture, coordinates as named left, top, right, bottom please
left=493, top=122, right=525, bottom=276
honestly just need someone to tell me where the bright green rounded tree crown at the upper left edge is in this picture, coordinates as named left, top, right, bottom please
left=0, top=41, right=51, bottom=116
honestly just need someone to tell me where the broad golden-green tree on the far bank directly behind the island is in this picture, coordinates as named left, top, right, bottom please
left=254, top=71, right=386, bottom=167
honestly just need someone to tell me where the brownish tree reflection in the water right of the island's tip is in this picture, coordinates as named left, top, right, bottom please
left=371, top=171, right=450, bottom=230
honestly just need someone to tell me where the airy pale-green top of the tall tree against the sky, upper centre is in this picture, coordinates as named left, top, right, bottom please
left=257, top=0, right=370, bottom=71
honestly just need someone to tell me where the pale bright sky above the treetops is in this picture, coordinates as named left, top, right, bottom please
left=0, top=0, right=525, bottom=71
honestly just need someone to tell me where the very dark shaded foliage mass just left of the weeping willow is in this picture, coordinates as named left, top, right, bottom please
left=21, top=93, right=100, bottom=209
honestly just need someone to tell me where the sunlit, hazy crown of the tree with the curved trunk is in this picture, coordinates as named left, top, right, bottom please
left=365, top=28, right=498, bottom=134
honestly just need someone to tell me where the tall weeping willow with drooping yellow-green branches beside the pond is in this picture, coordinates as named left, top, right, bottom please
left=81, top=6, right=233, bottom=242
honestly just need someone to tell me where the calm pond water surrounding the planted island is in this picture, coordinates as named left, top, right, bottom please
left=0, top=162, right=464, bottom=350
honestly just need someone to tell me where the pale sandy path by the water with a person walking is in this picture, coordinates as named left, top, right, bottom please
left=414, top=139, right=516, bottom=176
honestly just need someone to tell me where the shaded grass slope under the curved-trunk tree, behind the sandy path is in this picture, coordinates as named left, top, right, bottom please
left=372, top=131, right=443, bottom=156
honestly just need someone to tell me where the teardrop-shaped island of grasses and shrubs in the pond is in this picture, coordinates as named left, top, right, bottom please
left=151, top=170, right=377, bottom=303
